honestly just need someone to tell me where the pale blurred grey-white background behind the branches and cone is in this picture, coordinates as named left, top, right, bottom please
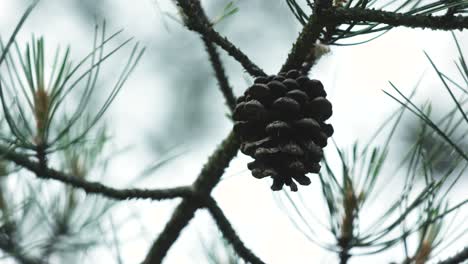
left=0, top=0, right=468, bottom=263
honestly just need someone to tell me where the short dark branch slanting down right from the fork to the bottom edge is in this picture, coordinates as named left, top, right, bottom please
left=206, top=197, right=265, bottom=264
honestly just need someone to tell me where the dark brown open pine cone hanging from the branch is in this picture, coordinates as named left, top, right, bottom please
left=233, top=70, right=333, bottom=191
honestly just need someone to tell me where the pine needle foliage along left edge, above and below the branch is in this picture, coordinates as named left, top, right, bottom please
left=0, top=3, right=143, bottom=263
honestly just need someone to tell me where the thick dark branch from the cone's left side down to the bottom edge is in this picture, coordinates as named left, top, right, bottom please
left=143, top=131, right=240, bottom=264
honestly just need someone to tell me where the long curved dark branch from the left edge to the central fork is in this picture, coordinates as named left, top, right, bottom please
left=0, top=145, right=191, bottom=200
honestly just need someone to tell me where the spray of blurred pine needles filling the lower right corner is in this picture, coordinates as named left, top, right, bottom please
left=278, top=70, right=468, bottom=263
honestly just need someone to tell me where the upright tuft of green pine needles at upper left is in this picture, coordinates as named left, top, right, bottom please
left=0, top=23, right=143, bottom=153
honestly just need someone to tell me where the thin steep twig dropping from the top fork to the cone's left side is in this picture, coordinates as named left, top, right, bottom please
left=202, top=36, right=236, bottom=112
